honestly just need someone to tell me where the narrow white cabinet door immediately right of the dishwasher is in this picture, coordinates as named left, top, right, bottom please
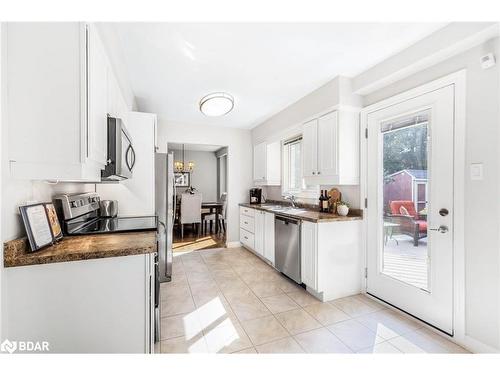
left=300, top=221, right=318, bottom=290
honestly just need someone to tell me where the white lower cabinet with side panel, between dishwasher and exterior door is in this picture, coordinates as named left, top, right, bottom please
left=301, top=220, right=363, bottom=301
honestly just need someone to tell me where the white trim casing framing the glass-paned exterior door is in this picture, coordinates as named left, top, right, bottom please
left=360, top=69, right=468, bottom=351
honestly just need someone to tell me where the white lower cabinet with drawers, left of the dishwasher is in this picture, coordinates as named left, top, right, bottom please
left=240, top=207, right=274, bottom=265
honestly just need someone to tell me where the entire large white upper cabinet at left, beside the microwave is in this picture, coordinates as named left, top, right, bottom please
left=2, top=22, right=125, bottom=181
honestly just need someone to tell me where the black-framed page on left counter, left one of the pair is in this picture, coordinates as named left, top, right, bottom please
left=19, top=203, right=54, bottom=251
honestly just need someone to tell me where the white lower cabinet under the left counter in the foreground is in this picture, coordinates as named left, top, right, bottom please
left=4, top=254, right=155, bottom=353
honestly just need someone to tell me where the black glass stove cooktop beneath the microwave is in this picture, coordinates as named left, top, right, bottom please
left=67, top=216, right=157, bottom=235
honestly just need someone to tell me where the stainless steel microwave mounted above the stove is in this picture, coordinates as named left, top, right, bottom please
left=101, top=116, right=136, bottom=181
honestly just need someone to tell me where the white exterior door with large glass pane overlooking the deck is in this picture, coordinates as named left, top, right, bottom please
left=365, top=85, right=454, bottom=334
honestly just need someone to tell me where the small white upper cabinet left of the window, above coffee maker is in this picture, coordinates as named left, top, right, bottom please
left=253, top=142, right=281, bottom=185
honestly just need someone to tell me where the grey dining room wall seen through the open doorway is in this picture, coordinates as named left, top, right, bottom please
left=174, top=150, right=218, bottom=202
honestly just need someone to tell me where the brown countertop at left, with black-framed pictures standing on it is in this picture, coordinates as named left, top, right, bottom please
left=4, top=231, right=157, bottom=267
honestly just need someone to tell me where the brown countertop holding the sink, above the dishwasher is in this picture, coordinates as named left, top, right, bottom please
left=240, top=203, right=363, bottom=223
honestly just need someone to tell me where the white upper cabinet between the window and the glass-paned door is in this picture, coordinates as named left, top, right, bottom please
left=302, top=111, right=359, bottom=185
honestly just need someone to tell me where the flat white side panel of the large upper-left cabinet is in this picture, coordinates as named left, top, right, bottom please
left=6, top=22, right=86, bottom=180
